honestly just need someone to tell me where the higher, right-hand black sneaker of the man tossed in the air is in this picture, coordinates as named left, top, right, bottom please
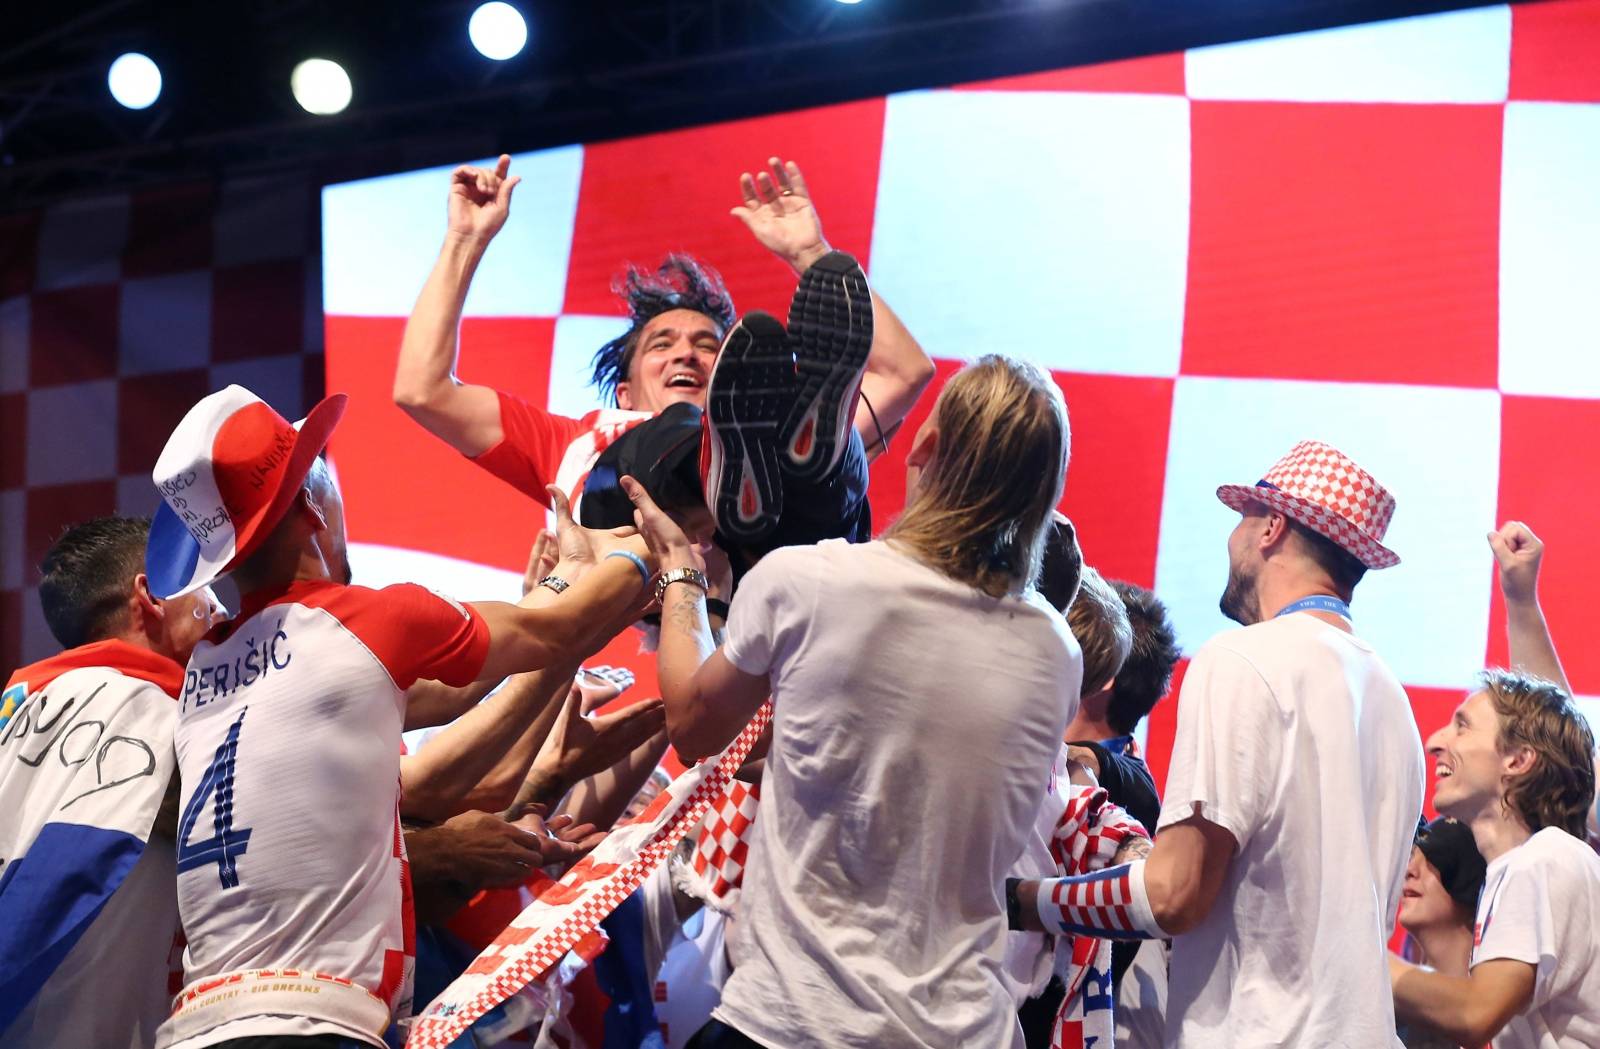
left=778, top=251, right=872, bottom=481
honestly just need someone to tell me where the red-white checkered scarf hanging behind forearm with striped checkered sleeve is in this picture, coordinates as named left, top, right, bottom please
left=1050, top=784, right=1149, bottom=1049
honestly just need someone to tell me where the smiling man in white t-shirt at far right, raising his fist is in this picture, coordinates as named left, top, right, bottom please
left=1389, top=521, right=1600, bottom=1049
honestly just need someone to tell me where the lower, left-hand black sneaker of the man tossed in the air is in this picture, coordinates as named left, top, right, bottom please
left=701, top=310, right=795, bottom=542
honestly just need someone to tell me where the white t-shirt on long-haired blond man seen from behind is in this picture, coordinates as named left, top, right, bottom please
left=715, top=540, right=1083, bottom=1049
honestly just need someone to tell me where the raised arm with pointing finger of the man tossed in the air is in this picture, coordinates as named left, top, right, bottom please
left=394, top=155, right=522, bottom=456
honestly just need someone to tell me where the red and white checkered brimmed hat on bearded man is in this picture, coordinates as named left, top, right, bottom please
left=1216, top=441, right=1400, bottom=568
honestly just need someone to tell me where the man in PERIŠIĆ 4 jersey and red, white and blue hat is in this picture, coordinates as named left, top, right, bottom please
left=146, top=385, right=654, bottom=1049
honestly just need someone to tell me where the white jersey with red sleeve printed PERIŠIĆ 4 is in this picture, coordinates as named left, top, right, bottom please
left=158, top=580, right=488, bottom=1049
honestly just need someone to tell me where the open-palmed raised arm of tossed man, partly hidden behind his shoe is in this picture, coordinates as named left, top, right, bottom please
left=733, top=157, right=934, bottom=461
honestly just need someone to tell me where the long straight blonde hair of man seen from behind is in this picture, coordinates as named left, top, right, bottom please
left=883, top=355, right=1072, bottom=596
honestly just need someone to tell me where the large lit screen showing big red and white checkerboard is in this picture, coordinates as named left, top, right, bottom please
left=323, top=0, right=1600, bottom=812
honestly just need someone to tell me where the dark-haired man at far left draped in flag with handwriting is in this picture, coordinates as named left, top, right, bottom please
left=0, top=517, right=216, bottom=1049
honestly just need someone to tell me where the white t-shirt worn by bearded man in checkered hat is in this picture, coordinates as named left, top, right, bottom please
left=1141, top=612, right=1422, bottom=1049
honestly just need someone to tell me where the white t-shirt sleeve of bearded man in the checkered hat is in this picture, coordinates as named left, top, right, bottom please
left=1157, top=643, right=1283, bottom=849
